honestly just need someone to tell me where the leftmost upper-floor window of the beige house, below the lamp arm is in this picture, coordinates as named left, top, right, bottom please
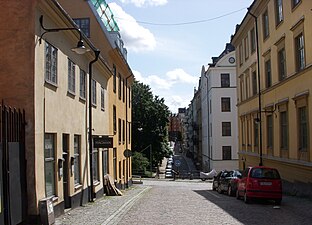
left=45, top=42, right=57, bottom=85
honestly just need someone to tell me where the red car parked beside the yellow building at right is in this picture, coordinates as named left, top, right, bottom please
left=236, top=166, right=282, bottom=205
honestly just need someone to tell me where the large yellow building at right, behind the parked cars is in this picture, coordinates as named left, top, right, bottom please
left=232, top=0, right=312, bottom=192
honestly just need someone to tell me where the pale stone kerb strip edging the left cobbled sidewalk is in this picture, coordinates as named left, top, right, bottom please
left=101, top=187, right=152, bottom=225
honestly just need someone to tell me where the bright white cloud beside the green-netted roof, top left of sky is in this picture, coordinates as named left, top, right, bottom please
left=109, top=2, right=156, bottom=52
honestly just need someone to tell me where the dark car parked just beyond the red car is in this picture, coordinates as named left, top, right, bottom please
left=213, top=170, right=242, bottom=196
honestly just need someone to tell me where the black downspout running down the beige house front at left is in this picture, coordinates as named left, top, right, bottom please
left=89, top=49, right=100, bottom=202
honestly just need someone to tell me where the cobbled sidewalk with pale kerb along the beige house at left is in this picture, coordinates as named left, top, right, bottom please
left=55, top=185, right=151, bottom=225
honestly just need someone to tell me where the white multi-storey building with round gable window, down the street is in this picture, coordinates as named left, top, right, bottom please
left=201, top=44, right=238, bottom=171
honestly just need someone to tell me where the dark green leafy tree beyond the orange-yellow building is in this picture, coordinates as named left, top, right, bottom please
left=132, top=81, right=170, bottom=171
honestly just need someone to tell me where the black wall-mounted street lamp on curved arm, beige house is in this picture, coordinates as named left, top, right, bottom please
left=39, top=15, right=90, bottom=55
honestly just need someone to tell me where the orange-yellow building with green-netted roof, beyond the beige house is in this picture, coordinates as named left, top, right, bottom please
left=59, top=0, right=134, bottom=192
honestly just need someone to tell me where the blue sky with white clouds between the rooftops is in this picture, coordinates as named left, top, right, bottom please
left=106, top=0, right=253, bottom=113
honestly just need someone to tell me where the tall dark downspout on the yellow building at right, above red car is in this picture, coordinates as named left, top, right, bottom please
left=248, top=8, right=263, bottom=166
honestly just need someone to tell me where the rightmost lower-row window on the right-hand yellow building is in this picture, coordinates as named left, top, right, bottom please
left=298, top=106, right=308, bottom=151
